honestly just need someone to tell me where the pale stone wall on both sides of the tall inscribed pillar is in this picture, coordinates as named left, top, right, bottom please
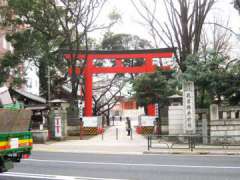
left=168, top=104, right=240, bottom=144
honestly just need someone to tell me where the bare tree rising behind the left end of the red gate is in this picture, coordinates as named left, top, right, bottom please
left=49, top=0, right=106, bottom=99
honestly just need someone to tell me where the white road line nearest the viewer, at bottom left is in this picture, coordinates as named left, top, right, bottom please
left=0, top=172, right=127, bottom=180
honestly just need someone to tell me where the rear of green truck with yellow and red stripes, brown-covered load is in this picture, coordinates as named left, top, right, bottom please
left=0, top=105, right=32, bottom=172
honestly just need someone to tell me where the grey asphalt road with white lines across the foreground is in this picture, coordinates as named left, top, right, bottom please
left=0, top=152, right=240, bottom=180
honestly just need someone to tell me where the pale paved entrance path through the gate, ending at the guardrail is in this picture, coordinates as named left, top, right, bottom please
left=33, top=120, right=147, bottom=154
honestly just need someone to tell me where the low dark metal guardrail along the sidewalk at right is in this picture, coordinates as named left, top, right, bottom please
left=147, top=135, right=240, bottom=151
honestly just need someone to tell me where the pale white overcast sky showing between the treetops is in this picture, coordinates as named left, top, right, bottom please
left=90, top=0, right=240, bottom=55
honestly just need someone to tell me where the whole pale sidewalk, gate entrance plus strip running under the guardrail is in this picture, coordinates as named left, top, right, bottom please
left=33, top=120, right=240, bottom=155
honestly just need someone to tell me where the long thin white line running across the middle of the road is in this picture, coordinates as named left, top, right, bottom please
left=24, top=159, right=240, bottom=169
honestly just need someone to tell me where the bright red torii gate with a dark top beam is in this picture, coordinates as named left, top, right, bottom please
left=64, top=48, right=175, bottom=116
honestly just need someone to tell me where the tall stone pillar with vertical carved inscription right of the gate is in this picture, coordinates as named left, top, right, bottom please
left=183, top=81, right=196, bottom=134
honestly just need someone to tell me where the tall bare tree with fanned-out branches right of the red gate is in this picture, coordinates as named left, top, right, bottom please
left=131, top=0, right=215, bottom=71
